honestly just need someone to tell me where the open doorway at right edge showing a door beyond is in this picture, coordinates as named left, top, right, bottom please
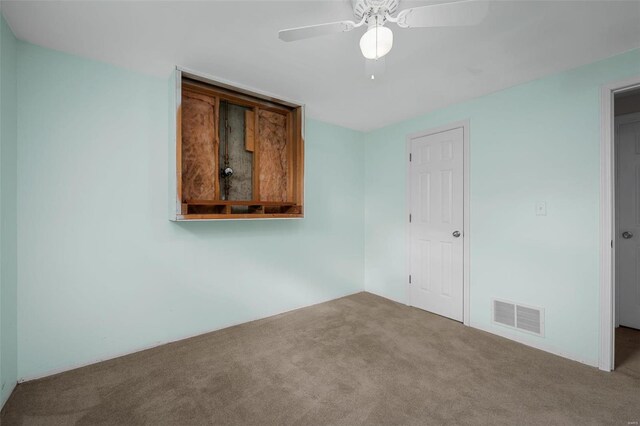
left=613, top=88, right=640, bottom=373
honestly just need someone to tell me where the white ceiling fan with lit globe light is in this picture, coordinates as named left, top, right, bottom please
left=279, top=0, right=488, bottom=60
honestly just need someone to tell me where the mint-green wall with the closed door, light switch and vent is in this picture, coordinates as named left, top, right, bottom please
left=365, top=50, right=640, bottom=364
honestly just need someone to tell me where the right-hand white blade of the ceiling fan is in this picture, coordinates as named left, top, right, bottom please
left=396, top=0, right=489, bottom=28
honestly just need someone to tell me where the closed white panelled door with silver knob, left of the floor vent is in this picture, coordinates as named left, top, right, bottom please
left=409, top=127, right=464, bottom=321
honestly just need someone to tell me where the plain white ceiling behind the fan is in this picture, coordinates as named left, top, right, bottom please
left=2, top=0, right=640, bottom=130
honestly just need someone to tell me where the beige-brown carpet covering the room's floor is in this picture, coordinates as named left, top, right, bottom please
left=2, top=293, right=640, bottom=426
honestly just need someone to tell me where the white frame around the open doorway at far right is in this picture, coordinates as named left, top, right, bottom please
left=598, top=76, right=640, bottom=371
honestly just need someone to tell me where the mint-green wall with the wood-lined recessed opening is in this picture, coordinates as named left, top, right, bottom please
left=18, top=43, right=364, bottom=378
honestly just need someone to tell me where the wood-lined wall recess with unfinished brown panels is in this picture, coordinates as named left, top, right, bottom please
left=170, top=70, right=304, bottom=221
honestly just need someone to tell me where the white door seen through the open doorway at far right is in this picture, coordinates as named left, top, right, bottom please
left=615, top=114, right=640, bottom=329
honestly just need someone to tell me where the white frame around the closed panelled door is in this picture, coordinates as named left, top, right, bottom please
left=405, top=119, right=471, bottom=326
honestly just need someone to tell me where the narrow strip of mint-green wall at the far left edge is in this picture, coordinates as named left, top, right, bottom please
left=0, top=15, right=18, bottom=408
